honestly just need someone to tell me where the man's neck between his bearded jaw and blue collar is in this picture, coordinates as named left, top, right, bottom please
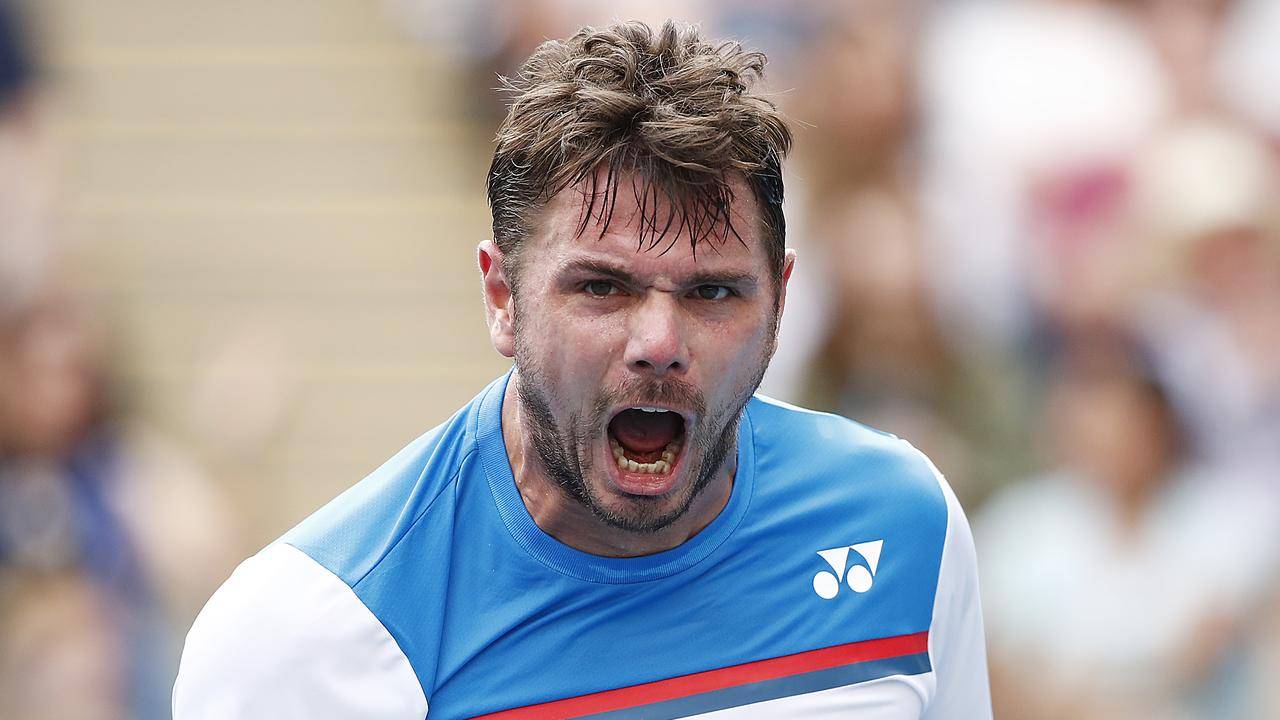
left=502, top=375, right=736, bottom=557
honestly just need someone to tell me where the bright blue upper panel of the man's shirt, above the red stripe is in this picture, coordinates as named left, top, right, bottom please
left=290, top=374, right=947, bottom=720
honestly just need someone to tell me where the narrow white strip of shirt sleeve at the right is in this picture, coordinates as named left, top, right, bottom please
left=924, top=461, right=992, bottom=720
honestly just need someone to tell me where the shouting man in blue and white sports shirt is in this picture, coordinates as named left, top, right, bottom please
left=174, top=23, right=991, bottom=720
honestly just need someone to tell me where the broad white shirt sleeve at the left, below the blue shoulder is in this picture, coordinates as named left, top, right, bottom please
left=173, top=543, right=426, bottom=720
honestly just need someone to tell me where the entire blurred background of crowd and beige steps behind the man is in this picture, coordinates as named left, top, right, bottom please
left=0, top=0, right=1280, bottom=720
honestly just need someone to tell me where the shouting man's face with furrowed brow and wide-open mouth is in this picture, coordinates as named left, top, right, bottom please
left=496, top=176, right=791, bottom=532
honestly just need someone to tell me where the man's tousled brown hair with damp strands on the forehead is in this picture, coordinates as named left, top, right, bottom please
left=488, top=20, right=791, bottom=283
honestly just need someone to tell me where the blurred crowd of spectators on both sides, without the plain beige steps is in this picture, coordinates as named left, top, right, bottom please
left=0, top=0, right=1280, bottom=720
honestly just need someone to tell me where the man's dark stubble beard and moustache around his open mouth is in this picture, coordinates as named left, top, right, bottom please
left=516, top=338, right=772, bottom=533
